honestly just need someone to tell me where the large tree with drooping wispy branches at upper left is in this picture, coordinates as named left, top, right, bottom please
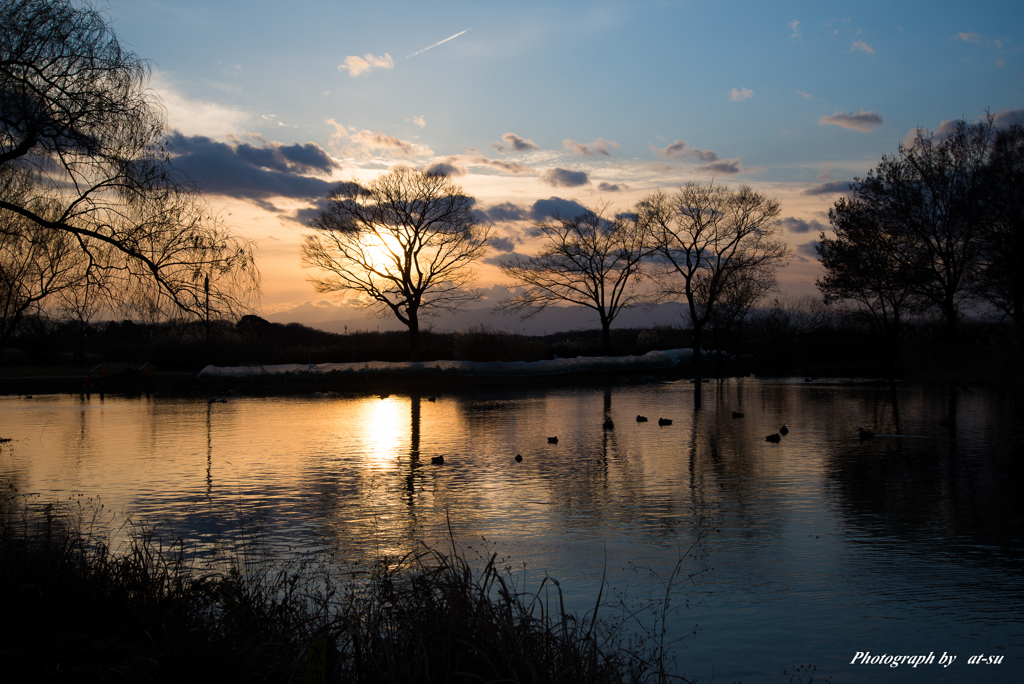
left=0, top=0, right=259, bottom=333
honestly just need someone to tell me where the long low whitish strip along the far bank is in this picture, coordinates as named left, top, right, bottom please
left=200, top=349, right=696, bottom=378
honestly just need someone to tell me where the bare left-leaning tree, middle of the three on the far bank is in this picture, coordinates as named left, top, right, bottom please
left=498, top=202, right=646, bottom=353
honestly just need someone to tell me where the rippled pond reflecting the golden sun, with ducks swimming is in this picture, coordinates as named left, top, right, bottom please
left=0, top=378, right=1024, bottom=684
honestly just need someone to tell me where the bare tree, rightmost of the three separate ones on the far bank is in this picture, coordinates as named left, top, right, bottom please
left=636, top=181, right=790, bottom=361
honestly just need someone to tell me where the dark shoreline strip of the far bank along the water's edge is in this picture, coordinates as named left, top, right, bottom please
left=0, top=348, right=1024, bottom=397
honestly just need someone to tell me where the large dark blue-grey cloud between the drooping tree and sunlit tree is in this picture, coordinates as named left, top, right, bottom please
left=167, top=132, right=339, bottom=211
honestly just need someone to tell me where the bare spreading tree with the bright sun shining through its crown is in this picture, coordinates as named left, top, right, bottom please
left=302, top=167, right=490, bottom=360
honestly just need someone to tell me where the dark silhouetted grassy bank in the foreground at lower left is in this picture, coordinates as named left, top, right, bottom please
left=0, top=486, right=699, bottom=683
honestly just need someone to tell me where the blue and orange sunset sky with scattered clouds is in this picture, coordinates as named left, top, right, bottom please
left=101, top=0, right=1024, bottom=323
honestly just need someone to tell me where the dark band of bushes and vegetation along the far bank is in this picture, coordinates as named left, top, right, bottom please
left=0, top=299, right=1024, bottom=392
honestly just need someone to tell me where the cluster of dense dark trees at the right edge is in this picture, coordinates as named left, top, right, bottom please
left=817, top=116, right=1024, bottom=364
